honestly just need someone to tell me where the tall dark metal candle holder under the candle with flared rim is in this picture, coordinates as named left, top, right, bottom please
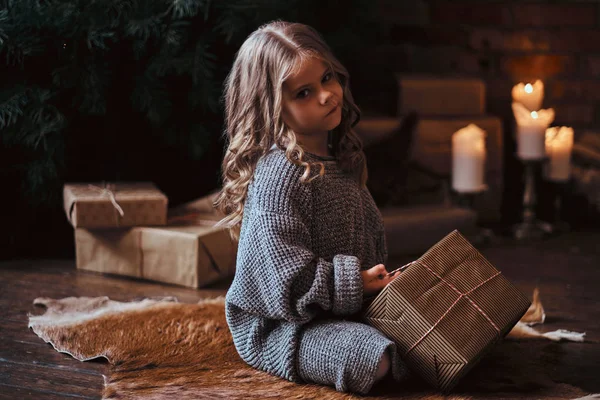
left=513, top=158, right=552, bottom=240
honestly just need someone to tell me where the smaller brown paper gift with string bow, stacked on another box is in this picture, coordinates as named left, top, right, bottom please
left=63, top=182, right=168, bottom=229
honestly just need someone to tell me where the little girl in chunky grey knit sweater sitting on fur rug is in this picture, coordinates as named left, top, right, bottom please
left=215, top=21, right=406, bottom=394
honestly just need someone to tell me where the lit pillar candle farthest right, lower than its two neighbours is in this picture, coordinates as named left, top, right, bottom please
left=546, top=126, right=573, bottom=181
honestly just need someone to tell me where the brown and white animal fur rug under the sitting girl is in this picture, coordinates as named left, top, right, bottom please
left=29, top=293, right=587, bottom=400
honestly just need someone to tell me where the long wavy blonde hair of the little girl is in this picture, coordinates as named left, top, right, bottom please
left=214, top=21, right=367, bottom=239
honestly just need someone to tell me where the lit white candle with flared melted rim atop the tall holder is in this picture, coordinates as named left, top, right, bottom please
left=512, top=103, right=554, bottom=160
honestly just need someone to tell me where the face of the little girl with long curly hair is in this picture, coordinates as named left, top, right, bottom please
left=282, top=57, right=344, bottom=141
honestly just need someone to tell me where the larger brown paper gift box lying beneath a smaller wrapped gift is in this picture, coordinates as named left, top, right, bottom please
left=75, top=225, right=237, bottom=288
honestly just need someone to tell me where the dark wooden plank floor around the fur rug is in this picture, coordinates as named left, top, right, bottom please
left=0, top=232, right=600, bottom=399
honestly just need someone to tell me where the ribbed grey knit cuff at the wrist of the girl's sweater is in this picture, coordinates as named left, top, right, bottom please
left=332, top=255, right=363, bottom=315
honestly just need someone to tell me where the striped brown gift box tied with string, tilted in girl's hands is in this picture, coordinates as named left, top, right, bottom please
left=364, top=230, right=530, bottom=392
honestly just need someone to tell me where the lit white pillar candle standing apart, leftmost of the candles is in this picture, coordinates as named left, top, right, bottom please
left=452, top=124, right=486, bottom=193
